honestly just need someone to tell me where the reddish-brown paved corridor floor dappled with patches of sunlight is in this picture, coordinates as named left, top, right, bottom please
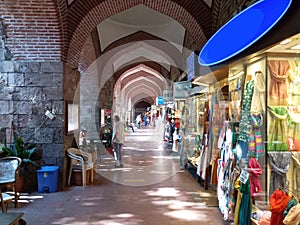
left=8, top=125, right=226, bottom=225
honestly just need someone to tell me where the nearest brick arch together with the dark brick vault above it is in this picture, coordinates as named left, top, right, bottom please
left=63, top=0, right=218, bottom=67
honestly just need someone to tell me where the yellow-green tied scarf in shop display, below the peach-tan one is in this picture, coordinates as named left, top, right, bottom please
left=268, top=107, right=288, bottom=151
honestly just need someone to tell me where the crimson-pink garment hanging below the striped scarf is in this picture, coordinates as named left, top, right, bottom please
left=248, top=158, right=262, bottom=196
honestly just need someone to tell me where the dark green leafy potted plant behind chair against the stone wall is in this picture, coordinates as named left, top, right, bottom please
left=2, top=136, right=39, bottom=189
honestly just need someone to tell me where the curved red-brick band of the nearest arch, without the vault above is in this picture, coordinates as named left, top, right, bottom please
left=66, top=0, right=207, bottom=67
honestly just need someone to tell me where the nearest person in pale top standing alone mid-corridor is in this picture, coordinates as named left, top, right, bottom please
left=112, top=115, right=124, bottom=167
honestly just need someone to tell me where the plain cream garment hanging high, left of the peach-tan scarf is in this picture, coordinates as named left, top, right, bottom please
left=250, top=71, right=266, bottom=113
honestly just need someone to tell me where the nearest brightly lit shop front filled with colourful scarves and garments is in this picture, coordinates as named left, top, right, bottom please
left=195, top=1, right=300, bottom=224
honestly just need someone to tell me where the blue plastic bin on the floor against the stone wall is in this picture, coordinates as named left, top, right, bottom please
left=37, top=166, right=59, bottom=193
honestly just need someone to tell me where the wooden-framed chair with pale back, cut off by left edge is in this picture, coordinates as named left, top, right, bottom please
left=0, top=157, right=22, bottom=212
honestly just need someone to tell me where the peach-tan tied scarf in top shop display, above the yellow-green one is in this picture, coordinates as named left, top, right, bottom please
left=268, top=60, right=290, bottom=105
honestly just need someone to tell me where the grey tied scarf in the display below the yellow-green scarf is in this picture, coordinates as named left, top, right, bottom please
left=268, top=152, right=291, bottom=193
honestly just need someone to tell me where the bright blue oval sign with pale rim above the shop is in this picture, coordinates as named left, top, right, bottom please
left=198, top=0, right=292, bottom=66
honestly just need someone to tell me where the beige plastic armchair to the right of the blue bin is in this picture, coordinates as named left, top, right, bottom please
left=67, top=148, right=94, bottom=186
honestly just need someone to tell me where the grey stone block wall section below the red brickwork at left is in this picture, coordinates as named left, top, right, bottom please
left=0, top=61, right=64, bottom=168
